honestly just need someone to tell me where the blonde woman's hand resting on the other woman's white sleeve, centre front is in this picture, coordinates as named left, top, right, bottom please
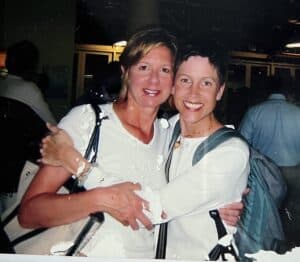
left=101, top=182, right=153, bottom=230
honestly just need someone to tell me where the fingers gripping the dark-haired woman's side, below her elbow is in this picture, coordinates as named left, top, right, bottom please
left=219, top=188, right=250, bottom=226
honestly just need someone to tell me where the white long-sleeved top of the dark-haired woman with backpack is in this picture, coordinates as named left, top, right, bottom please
left=160, top=126, right=250, bottom=260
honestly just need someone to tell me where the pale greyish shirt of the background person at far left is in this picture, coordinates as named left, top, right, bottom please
left=0, top=74, right=56, bottom=124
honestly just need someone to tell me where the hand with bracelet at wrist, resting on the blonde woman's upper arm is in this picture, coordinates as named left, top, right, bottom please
left=39, top=124, right=89, bottom=174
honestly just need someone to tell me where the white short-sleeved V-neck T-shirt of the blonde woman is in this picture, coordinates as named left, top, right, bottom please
left=59, top=104, right=169, bottom=258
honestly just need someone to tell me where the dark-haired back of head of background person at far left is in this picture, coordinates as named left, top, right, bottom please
left=5, top=40, right=39, bottom=78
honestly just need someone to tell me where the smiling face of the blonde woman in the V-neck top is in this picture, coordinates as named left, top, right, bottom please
left=127, top=46, right=173, bottom=108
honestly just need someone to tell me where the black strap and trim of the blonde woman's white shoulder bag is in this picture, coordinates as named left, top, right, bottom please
left=1, top=104, right=108, bottom=256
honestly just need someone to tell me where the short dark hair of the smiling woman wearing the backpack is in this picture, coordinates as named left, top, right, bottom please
left=174, top=44, right=228, bottom=85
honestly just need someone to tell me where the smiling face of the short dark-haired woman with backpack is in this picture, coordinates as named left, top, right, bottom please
left=173, top=56, right=224, bottom=124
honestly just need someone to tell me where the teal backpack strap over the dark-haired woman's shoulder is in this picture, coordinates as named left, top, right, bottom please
left=192, top=127, right=240, bottom=166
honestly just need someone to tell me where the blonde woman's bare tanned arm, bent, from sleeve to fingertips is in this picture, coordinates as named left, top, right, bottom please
left=19, top=166, right=152, bottom=229
